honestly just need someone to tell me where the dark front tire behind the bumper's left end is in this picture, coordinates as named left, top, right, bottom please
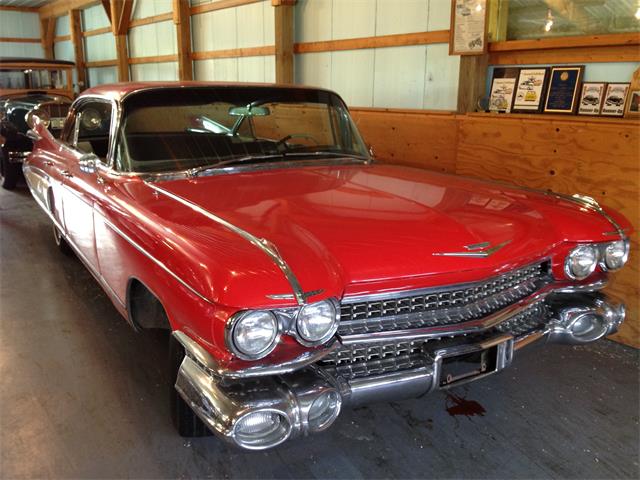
left=169, top=335, right=211, bottom=437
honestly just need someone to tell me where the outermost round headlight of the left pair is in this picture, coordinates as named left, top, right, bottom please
left=228, top=310, right=279, bottom=360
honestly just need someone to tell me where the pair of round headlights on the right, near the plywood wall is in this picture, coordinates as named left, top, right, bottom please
left=564, top=239, right=629, bottom=280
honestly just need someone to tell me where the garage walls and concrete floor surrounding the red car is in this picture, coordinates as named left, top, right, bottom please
left=0, top=0, right=640, bottom=478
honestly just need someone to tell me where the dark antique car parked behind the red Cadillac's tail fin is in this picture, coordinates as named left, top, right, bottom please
left=0, top=57, right=74, bottom=190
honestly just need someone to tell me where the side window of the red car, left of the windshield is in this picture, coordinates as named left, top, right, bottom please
left=74, top=102, right=111, bottom=161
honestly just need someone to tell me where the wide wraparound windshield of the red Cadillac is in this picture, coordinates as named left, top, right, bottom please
left=116, top=87, right=368, bottom=172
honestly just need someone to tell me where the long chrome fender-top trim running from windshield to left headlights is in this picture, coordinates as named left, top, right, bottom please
left=145, top=182, right=306, bottom=305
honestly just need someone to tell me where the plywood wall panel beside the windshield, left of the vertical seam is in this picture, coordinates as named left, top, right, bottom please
left=350, top=108, right=457, bottom=173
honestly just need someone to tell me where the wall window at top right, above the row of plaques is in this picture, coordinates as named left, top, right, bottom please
left=497, top=0, right=640, bottom=40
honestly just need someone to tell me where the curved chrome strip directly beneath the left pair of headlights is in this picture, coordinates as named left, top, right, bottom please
left=173, top=330, right=340, bottom=379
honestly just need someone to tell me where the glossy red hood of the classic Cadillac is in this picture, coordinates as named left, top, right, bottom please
left=148, top=164, right=612, bottom=295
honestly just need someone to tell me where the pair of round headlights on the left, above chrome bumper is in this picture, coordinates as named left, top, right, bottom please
left=227, top=299, right=340, bottom=360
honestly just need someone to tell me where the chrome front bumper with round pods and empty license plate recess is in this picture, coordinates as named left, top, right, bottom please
left=174, top=293, right=625, bottom=450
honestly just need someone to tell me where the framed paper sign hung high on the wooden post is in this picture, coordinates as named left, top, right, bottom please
left=449, top=0, right=487, bottom=55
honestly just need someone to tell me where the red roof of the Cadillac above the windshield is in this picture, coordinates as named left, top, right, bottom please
left=80, top=81, right=330, bottom=101
